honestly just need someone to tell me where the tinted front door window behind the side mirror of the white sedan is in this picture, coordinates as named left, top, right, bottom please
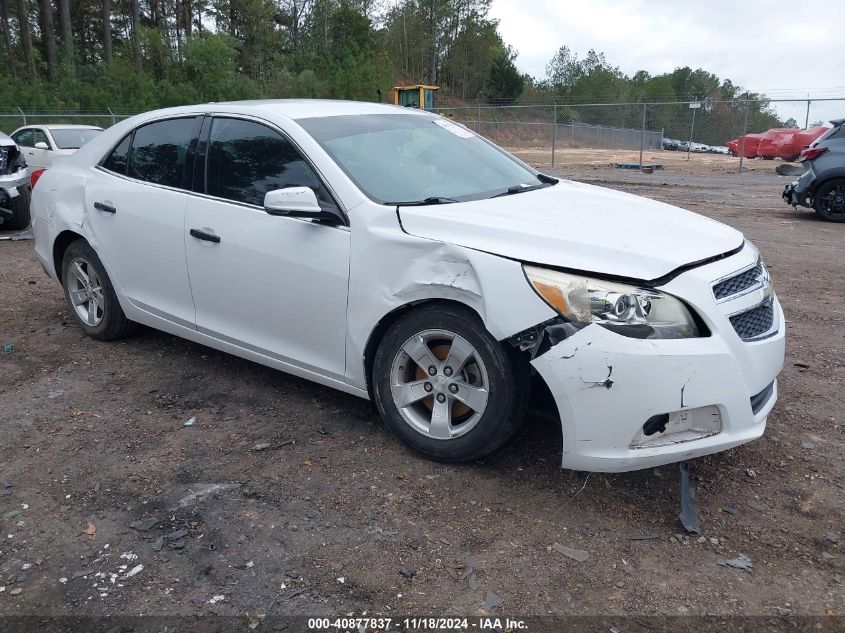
left=206, top=118, right=324, bottom=206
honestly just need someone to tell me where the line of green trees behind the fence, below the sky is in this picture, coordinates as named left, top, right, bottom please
left=0, top=0, right=782, bottom=136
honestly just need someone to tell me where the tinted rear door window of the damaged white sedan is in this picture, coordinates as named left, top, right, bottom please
left=127, top=118, right=194, bottom=187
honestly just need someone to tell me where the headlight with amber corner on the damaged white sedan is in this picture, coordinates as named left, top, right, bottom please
left=523, top=266, right=699, bottom=338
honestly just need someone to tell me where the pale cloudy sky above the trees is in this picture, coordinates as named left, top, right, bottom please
left=491, top=0, right=845, bottom=102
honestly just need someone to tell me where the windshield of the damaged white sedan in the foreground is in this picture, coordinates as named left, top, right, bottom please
left=297, top=114, right=553, bottom=204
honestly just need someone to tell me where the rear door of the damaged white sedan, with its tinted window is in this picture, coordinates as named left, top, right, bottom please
left=84, top=117, right=200, bottom=328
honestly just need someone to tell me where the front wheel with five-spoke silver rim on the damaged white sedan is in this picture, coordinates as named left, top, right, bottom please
left=371, top=304, right=529, bottom=462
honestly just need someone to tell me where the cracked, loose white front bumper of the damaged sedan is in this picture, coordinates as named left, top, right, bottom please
left=532, top=245, right=784, bottom=472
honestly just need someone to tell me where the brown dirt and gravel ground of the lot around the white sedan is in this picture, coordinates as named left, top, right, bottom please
left=0, top=165, right=845, bottom=630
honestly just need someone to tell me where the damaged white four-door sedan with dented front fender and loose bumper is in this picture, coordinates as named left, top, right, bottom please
left=32, top=101, right=785, bottom=471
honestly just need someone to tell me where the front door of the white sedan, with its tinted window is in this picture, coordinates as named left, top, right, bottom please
left=186, top=117, right=350, bottom=377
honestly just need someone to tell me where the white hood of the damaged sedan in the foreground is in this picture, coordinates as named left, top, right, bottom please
left=399, top=181, right=743, bottom=280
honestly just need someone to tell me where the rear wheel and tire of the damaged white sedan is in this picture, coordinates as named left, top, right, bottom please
left=62, top=240, right=135, bottom=341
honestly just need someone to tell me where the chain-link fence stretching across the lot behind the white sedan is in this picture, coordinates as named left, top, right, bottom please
left=0, top=97, right=845, bottom=173
